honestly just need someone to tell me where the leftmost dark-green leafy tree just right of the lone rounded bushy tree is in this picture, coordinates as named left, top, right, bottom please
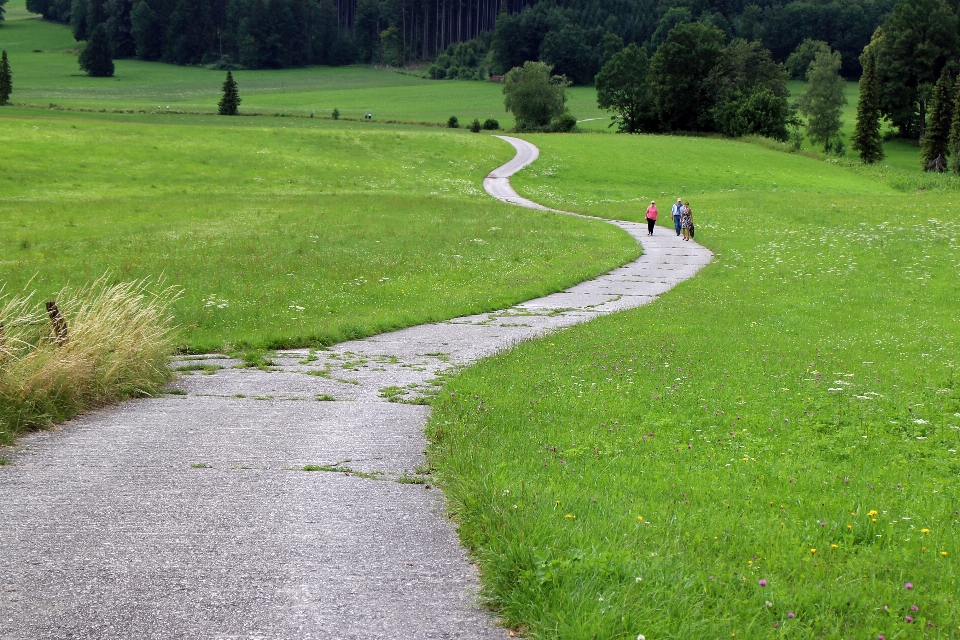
left=597, top=43, right=654, bottom=133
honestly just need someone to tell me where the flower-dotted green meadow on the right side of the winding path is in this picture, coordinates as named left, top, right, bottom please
left=429, top=136, right=960, bottom=639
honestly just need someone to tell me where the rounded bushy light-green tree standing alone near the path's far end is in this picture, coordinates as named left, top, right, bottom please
left=503, top=60, right=568, bottom=131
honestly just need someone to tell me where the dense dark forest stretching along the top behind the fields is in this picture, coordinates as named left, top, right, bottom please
left=20, top=0, right=892, bottom=83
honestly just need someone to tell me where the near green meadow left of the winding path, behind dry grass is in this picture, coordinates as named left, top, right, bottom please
left=0, top=108, right=638, bottom=351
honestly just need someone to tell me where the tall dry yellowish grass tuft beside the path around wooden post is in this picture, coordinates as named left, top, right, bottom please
left=0, top=275, right=180, bottom=444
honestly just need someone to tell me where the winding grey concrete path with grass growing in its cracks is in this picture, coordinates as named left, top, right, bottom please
left=0, top=137, right=711, bottom=640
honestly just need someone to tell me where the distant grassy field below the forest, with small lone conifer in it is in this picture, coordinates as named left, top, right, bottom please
left=0, top=0, right=609, bottom=129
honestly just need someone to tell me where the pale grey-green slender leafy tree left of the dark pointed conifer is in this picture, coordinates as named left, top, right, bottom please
left=800, top=51, right=847, bottom=151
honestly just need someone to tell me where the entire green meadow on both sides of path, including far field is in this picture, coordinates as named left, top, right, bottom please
left=0, top=0, right=960, bottom=640
